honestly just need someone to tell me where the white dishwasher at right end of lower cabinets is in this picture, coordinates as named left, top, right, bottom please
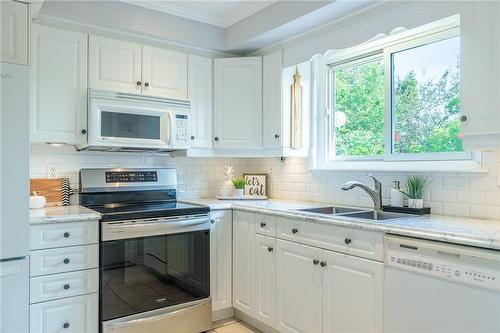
left=384, top=235, right=500, bottom=333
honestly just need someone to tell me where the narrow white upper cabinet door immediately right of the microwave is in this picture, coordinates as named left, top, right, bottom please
left=188, top=55, right=212, bottom=148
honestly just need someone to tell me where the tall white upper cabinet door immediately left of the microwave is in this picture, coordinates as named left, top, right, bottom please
left=31, top=24, right=87, bottom=144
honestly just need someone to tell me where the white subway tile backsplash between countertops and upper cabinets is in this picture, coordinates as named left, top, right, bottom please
left=31, top=145, right=500, bottom=219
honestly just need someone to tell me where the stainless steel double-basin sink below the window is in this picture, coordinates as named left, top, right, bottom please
left=296, top=206, right=411, bottom=221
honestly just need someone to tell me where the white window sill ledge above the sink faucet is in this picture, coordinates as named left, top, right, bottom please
left=312, top=160, right=490, bottom=173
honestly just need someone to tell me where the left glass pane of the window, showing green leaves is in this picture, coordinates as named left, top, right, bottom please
left=333, top=60, right=384, bottom=156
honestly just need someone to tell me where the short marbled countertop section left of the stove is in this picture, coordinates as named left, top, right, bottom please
left=30, top=205, right=101, bottom=224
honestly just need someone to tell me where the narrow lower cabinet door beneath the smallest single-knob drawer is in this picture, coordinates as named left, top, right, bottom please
left=255, top=235, right=276, bottom=327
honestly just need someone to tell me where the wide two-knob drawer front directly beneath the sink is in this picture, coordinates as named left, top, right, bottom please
left=276, top=217, right=384, bottom=261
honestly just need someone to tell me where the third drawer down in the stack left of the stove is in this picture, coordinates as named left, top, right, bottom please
left=30, top=268, right=99, bottom=303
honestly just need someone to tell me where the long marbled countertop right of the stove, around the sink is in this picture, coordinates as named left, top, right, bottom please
left=185, top=199, right=500, bottom=250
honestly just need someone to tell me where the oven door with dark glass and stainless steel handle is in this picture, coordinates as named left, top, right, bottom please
left=100, top=215, right=210, bottom=327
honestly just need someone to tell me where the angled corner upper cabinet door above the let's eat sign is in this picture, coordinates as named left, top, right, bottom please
left=214, top=57, right=262, bottom=148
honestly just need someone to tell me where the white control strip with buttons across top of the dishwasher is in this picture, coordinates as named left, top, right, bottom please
left=387, top=250, right=500, bottom=291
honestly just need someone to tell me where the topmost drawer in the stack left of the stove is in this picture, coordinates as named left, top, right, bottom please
left=30, top=221, right=99, bottom=250
